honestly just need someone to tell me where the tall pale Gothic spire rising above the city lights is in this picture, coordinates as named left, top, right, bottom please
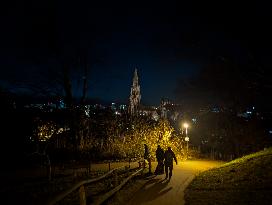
left=129, top=68, right=141, bottom=115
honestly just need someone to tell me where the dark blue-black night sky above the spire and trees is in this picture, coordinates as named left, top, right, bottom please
left=0, top=1, right=272, bottom=104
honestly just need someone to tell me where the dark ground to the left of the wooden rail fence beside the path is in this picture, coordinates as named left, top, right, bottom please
left=0, top=162, right=138, bottom=204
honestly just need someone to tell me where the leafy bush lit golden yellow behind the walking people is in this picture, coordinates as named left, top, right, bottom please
left=102, top=118, right=183, bottom=159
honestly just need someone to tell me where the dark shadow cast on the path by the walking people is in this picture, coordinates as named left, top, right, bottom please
left=129, top=179, right=173, bottom=205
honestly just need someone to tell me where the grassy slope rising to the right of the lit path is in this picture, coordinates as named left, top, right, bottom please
left=185, top=148, right=272, bottom=205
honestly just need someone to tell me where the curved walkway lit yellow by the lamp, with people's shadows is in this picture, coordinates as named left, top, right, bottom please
left=127, top=161, right=223, bottom=205
